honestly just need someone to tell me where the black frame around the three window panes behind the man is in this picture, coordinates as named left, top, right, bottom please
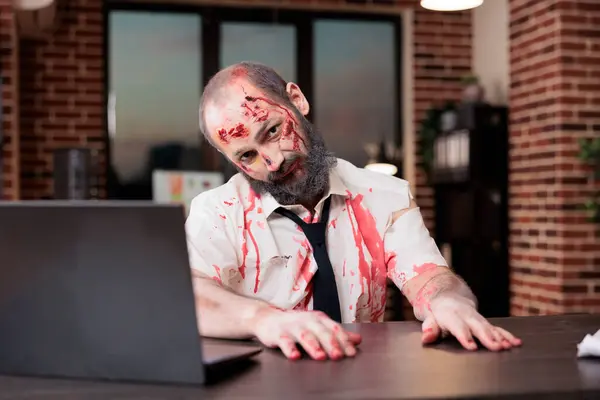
left=103, top=0, right=404, bottom=194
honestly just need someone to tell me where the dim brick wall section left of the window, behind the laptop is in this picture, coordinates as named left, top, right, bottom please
left=19, top=0, right=105, bottom=199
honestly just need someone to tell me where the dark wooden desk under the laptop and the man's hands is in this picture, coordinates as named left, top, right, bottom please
left=0, top=315, right=600, bottom=400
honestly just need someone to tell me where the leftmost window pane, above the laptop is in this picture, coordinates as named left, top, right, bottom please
left=108, top=11, right=202, bottom=199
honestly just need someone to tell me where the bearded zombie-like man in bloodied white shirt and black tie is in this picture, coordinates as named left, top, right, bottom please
left=186, top=63, right=520, bottom=360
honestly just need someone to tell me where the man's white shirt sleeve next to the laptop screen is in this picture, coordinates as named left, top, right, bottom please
left=185, top=193, right=238, bottom=286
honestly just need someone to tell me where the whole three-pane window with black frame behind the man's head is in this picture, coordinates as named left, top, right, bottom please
left=107, top=3, right=402, bottom=198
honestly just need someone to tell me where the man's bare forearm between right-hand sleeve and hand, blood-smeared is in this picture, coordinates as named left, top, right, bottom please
left=409, top=271, right=477, bottom=321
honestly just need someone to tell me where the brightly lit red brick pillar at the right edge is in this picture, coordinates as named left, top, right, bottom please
left=509, top=0, right=600, bottom=315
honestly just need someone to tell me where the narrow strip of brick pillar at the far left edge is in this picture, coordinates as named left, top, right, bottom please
left=0, top=0, right=19, bottom=200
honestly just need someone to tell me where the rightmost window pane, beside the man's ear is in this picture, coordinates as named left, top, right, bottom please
left=313, top=19, right=398, bottom=166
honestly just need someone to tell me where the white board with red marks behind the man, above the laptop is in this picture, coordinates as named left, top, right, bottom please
left=152, top=170, right=224, bottom=215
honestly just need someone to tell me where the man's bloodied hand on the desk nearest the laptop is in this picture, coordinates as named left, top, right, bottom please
left=252, top=307, right=362, bottom=360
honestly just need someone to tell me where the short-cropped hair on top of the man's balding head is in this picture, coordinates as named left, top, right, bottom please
left=198, top=61, right=292, bottom=146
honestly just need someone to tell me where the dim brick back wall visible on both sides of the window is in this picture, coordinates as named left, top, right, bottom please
left=4, top=0, right=471, bottom=216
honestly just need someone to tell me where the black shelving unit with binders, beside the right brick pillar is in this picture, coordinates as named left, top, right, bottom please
left=431, top=104, right=510, bottom=318
